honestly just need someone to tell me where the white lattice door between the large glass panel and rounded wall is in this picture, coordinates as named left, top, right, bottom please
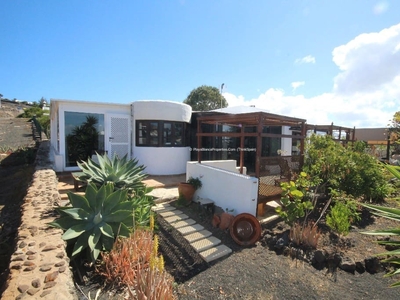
left=106, top=114, right=131, bottom=158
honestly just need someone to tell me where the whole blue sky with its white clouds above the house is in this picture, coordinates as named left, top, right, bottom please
left=0, top=0, right=400, bottom=127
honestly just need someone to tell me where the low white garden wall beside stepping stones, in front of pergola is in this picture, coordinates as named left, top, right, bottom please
left=186, top=162, right=258, bottom=216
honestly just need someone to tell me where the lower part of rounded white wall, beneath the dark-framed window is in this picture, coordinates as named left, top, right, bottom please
left=133, top=147, right=190, bottom=175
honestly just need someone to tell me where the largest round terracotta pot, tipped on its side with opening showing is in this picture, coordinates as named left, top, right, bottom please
left=230, top=213, right=261, bottom=246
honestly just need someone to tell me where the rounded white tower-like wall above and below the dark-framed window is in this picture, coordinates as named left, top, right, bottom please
left=132, top=100, right=192, bottom=175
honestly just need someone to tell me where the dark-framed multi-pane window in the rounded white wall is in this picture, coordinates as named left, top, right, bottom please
left=136, top=120, right=186, bottom=147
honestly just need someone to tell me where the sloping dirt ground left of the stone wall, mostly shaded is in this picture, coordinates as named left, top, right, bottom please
left=0, top=118, right=36, bottom=295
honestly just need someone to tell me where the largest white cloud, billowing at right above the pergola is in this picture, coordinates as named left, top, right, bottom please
left=224, top=24, right=400, bottom=128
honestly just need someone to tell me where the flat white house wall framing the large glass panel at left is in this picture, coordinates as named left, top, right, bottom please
left=50, top=99, right=131, bottom=172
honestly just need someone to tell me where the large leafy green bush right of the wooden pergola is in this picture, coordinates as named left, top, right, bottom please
left=303, top=135, right=390, bottom=202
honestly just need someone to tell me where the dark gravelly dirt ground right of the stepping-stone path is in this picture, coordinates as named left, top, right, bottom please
left=158, top=199, right=400, bottom=300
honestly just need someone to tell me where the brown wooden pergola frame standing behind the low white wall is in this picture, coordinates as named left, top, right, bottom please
left=197, top=112, right=307, bottom=178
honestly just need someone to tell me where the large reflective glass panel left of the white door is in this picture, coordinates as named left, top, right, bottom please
left=64, top=111, right=104, bottom=167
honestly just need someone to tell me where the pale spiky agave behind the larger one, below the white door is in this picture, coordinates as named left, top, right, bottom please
left=78, top=154, right=147, bottom=192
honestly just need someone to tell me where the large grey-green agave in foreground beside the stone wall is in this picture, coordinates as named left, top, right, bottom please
left=50, top=183, right=135, bottom=261
